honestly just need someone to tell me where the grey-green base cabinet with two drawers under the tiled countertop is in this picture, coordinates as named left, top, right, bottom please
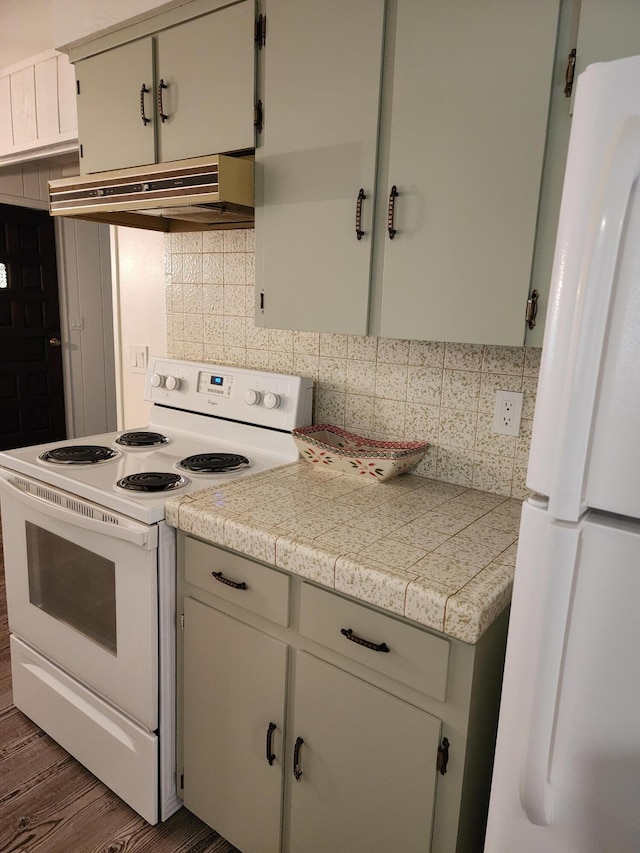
left=178, top=533, right=506, bottom=853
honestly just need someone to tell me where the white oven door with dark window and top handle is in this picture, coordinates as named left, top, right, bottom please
left=0, top=470, right=158, bottom=731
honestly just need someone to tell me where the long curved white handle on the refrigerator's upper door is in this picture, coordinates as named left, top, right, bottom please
left=549, top=116, right=640, bottom=521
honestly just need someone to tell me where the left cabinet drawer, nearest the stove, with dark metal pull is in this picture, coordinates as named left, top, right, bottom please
left=184, top=536, right=290, bottom=627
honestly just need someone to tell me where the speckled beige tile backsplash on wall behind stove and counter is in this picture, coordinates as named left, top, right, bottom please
left=165, top=229, right=541, bottom=498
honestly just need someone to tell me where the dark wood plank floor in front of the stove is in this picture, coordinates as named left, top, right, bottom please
left=0, top=533, right=238, bottom=853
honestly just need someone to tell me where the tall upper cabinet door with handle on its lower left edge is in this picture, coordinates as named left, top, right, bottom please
left=379, top=0, right=559, bottom=345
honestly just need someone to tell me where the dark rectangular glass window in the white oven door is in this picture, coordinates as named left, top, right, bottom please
left=26, top=521, right=118, bottom=655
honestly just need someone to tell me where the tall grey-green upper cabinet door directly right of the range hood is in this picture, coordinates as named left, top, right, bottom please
left=256, top=0, right=384, bottom=334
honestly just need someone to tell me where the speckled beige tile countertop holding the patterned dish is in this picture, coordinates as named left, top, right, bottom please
left=166, top=460, right=522, bottom=643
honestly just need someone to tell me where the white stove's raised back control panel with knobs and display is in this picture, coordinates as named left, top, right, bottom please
left=145, top=356, right=313, bottom=431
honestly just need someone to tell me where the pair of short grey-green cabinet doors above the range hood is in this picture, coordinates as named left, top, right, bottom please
left=75, top=0, right=255, bottom=174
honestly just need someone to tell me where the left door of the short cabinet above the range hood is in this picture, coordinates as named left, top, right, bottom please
left=75, top=38, right=156, bottom=174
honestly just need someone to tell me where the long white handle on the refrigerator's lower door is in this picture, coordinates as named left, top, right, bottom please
left=520, top=522, right=580, bottom=826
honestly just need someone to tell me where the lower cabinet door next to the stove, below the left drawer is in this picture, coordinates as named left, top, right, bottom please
left=183, top=598, right=287, bottom=851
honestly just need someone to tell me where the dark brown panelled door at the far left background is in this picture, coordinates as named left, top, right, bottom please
left=0, top=204, right=66, bottom=450
